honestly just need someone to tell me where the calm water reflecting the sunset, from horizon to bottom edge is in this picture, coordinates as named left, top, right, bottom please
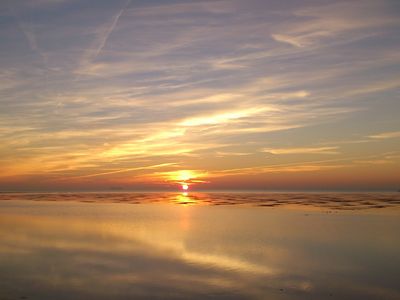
left=0, top=193, right=400, bottom=299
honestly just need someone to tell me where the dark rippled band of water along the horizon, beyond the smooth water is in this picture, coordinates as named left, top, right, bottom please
left=0, top=192, right=400, bottom=210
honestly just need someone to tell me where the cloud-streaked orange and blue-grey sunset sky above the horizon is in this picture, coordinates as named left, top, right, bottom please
left=0, top=0, right=400, bottom=191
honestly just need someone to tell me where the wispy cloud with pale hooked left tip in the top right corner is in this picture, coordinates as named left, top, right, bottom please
left=271, top=1, right=400, bottom=48
